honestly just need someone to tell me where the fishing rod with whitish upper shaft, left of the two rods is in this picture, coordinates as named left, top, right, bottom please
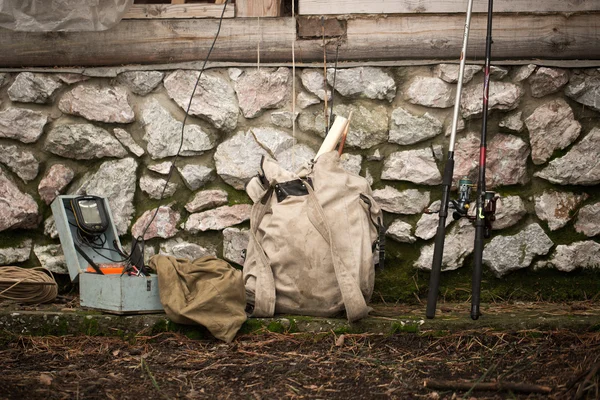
left=426, top=0, right=473, bottom=319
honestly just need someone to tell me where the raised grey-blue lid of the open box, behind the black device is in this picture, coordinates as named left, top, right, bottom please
left=51, top=195, right=122, bottom=282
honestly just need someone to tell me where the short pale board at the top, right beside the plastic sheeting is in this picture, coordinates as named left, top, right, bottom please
left=123, top=0, right=235, bottom=19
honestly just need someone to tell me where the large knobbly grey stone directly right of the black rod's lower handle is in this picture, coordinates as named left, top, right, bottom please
left=483, top=223, right=554, bottom=277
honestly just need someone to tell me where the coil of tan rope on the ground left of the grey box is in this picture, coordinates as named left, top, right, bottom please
left=0, top=267, right=58, bottom=304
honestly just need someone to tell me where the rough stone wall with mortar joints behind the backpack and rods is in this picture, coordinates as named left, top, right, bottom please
left=0, top=65, right=600, bottom=296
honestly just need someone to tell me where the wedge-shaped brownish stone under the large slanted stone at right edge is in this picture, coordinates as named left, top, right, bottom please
left=535, top=190, right=589, bottom=231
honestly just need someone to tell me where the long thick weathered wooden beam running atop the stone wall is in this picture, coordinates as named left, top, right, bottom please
left=0, top=12, right=600, bottom=67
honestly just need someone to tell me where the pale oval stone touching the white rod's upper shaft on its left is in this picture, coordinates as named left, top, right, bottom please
left=404, top=76, right=456, bottom=108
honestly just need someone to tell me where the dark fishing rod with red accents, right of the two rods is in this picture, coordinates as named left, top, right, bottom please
left=471, top=0, right=498, bottom=320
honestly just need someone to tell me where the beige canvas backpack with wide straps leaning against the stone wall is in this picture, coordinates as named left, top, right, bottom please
left=243, top=151, right=383, bottom=321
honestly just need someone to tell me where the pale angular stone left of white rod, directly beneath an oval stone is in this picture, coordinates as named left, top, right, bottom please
left=390, top=107, right=442, bottom=145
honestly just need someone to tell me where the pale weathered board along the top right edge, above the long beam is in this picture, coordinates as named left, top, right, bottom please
left=298, top=0, right=600, bottom=15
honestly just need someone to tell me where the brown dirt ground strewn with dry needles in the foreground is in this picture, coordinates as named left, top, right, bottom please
left=0, top=324, right=600, bottom=400
